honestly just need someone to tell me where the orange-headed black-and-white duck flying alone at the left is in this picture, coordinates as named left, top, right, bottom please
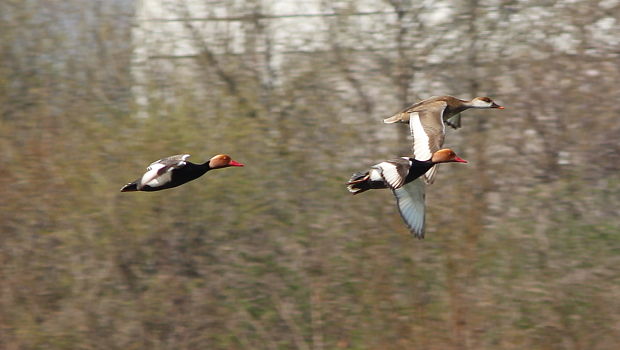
left=121, top=154, right=243, bottom=192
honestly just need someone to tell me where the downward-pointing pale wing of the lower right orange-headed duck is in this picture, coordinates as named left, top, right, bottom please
left=392, top=179, right=426, bottom=239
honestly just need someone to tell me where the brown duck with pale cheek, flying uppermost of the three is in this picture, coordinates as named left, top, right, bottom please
left=383, top=96, right=504, bottom=183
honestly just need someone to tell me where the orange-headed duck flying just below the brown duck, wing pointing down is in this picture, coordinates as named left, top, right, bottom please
left=347, top=149, right=467, bottom=239
